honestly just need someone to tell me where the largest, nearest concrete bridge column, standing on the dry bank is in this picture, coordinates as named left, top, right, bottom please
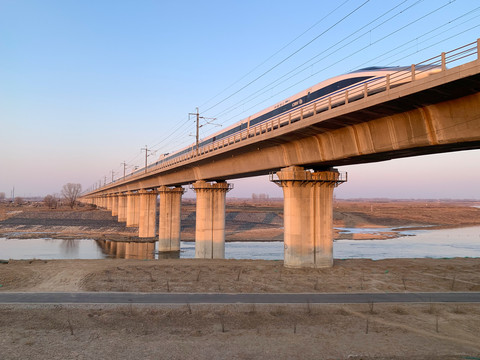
left=272, top=166, right=345, bottom=268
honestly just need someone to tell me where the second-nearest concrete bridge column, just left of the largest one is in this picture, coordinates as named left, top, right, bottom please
left=193, top=180, right=231, bottom=259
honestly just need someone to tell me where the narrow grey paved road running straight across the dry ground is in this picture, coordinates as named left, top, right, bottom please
left=0, top=292, right=480, bottom=304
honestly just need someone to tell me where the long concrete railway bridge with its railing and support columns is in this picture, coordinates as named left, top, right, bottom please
left=81, top=40, right=480, bottom=267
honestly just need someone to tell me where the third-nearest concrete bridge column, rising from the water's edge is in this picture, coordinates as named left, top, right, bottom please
left=158, top=186, right=184, bottom=252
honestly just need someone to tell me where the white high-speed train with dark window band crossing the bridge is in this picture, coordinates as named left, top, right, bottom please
left=135, top=65, right=441, bottom=173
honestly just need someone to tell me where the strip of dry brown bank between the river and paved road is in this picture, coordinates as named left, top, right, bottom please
left=0, top=258, right=480, bottom=293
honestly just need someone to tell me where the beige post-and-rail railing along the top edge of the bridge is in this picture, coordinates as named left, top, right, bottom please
left=92, top=39, right=480, bottom=191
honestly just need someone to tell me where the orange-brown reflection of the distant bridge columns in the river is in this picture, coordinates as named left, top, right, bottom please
left=97, top=240, right=155, bottom=260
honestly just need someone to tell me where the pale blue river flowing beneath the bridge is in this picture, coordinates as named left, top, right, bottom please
left=0, top=226, right=480, bottom=260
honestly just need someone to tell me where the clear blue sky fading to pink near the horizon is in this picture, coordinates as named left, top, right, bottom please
left=0, top=0, right=480, bottom=199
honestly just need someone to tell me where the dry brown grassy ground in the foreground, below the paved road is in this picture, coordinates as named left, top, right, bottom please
left=0, top=304, right=480, bottom=360
